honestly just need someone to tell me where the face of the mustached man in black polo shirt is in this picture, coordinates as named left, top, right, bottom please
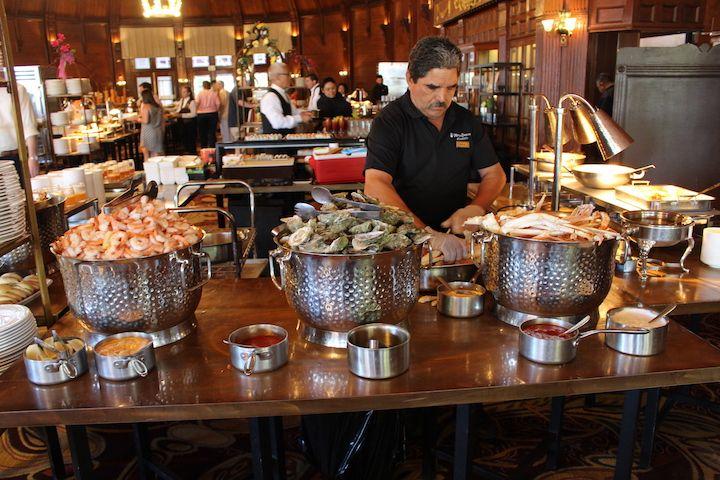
left=406, top=68, right=458, bottom=120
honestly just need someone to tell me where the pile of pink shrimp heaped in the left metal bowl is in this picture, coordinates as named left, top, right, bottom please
left=52, top=197, right=202, bottom=260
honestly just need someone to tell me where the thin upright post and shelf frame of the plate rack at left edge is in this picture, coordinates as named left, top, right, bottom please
left=0, top=0, right=56, bottom=325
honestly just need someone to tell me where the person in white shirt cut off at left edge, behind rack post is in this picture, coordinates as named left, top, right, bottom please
left=0, top=81, right=40, bottom=178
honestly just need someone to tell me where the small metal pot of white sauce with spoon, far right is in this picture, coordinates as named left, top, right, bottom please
left=605, top=307, right=670, bottom=356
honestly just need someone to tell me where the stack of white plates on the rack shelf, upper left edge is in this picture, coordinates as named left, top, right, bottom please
left=0, top=160, right=26, bottom=243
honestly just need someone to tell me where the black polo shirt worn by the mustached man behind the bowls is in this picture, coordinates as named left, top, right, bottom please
left=365, top=91, right=498, bottom=229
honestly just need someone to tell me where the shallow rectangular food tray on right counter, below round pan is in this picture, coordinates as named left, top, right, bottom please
left=615, top=185, right=715, bottom=212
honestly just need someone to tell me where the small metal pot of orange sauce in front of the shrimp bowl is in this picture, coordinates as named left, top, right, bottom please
left=95, top=332, right=155, bottom=380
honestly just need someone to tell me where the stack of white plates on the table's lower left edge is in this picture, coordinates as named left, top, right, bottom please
left=0, top=305, right=37, bottom=374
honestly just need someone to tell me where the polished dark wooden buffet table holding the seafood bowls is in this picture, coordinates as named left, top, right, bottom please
left=0, top=279, right=720, bottom=479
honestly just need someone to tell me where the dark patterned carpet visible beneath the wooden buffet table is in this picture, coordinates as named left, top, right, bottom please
left=0, top=315, right=720, bottom=480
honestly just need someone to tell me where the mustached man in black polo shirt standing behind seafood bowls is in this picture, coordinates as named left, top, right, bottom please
left=365, top=37, right=505, bottom=262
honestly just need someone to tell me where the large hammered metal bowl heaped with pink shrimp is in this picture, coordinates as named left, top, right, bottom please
left=51, top=197, right=210, bottom=341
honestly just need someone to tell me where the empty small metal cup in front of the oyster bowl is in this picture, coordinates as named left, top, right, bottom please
left=347, top=323, right=410, bottom=380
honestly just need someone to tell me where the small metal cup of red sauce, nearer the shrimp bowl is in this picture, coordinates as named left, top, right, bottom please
left=228, top=323, right=288, bottom=375
